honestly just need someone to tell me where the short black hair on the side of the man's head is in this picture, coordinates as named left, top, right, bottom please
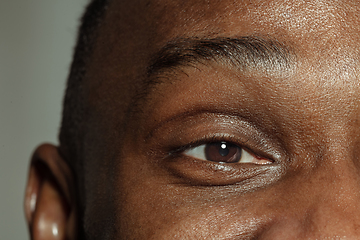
left=59, top=0, right=111, bottom=234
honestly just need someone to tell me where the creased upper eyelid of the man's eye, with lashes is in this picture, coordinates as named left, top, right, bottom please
left=145, top=112, right=288, bottom=162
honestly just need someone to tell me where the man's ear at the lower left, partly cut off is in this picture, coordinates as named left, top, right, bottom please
left=25, top=144, right=77, bottom=240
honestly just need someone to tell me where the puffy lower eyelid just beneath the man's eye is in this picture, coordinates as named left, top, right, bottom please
left=163, top=155, right=282, bottom=187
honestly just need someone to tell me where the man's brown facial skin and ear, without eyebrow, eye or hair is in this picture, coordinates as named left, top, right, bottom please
left=25, top=0, right=360, bottom=239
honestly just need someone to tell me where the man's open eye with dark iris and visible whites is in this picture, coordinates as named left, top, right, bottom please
left=184, top=142, right=272, bottom=164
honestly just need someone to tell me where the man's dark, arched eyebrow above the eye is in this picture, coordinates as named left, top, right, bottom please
left=147, top=36, right=295, bottom=77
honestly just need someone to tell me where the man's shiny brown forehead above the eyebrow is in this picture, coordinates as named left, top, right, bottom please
left=88, top=0, right=359, bottom=79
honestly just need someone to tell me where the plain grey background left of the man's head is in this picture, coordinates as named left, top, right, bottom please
left=0, top=0, right=88, bottom=240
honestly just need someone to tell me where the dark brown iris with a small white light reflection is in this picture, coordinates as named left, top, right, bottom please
left=205, top=142, right=241, bottom=163
